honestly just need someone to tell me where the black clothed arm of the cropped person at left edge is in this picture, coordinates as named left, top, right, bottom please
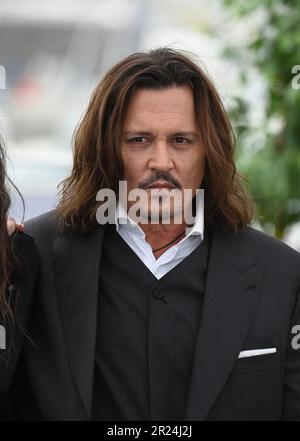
left=0, top=232, right=39, bottom=420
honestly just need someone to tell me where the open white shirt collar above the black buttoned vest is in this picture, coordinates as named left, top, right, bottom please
left=115, top=201, right=204, bottom=279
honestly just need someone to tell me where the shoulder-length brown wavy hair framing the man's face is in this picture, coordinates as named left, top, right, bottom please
left=57, top=47, right=254, bottom=233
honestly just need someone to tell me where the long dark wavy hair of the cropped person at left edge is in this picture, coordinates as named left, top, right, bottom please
left=0, top=137, right=24, bottom=327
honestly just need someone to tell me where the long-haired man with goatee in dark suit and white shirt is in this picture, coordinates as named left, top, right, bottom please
left=19, top=48, right=300, bottom=421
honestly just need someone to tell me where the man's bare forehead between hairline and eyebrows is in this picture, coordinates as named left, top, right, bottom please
left=124, top=86, right=196, bottom=129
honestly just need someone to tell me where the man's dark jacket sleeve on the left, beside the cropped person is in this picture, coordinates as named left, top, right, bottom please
left=11, top=210, right=59, bottom=421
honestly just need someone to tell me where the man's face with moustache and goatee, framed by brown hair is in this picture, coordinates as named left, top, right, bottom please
left=121, top=86, right=205, bottom=223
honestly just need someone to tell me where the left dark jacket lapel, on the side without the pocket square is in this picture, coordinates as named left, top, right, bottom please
left=53, top=226, right=104, bottom=419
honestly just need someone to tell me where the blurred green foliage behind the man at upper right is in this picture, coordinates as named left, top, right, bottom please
left=223, top=0, right=300, bottom=239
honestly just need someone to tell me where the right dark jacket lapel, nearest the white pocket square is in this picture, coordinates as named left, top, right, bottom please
left=184, top=227, right=263, bottom=421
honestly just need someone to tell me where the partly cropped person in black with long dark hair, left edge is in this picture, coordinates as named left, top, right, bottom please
left=0, top=138, right=38, bottom=420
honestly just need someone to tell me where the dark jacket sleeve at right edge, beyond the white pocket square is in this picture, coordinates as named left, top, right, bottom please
left=283, top=286, right=300, bottom=421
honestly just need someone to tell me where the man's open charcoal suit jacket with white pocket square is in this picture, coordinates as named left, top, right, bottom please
left=18, top=211, right=300, bottom=421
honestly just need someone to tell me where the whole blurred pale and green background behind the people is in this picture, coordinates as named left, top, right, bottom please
left=0, top=0, right=300, bottom=250
